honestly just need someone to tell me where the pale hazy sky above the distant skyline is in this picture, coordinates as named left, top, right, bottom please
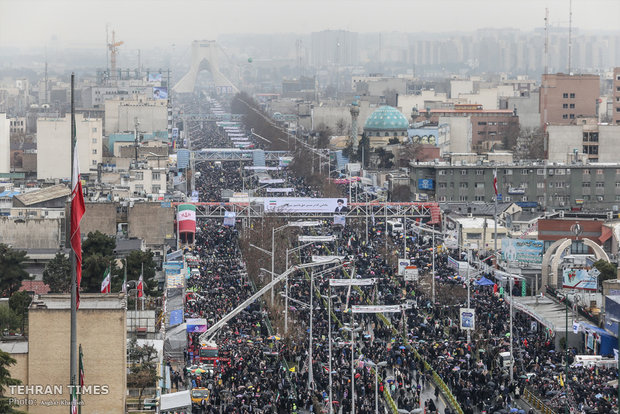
left=0, top=0, right=620, bottom=48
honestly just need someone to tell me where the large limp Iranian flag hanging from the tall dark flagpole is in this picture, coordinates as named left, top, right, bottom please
left=70, top=140, right=86, bottom=309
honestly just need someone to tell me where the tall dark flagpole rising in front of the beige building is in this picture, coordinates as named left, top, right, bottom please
left=68, top=73, right=77, bottom=412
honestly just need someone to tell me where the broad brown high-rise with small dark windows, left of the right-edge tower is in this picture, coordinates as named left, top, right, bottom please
left=540, top=73, right=600, bottom=127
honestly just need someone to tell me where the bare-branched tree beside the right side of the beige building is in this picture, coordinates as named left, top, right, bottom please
left=127, top=338, right=159, bottom=409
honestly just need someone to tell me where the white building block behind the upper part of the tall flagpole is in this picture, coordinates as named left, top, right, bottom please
left=37, top=114, right=103, bottom=180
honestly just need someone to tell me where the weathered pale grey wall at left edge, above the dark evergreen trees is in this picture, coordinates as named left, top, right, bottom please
left=0, top=217, right=64, bottom=249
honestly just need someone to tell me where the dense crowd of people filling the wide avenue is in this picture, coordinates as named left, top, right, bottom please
left=177, top=97, right=617, bottom=413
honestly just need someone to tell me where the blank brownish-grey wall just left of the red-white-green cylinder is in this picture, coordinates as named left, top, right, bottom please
left=128, top=203, right=175, bottom=247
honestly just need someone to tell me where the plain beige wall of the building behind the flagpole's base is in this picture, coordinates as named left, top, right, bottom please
left=21, top=295, right=127, bottom=414
